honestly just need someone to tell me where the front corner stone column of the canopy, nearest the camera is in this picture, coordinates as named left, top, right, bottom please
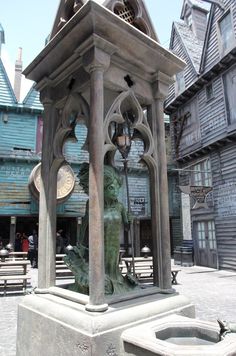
left=83, top=47, right=110, bottom=311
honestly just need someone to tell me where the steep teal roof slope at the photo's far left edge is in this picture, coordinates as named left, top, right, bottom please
left=0, top=58, right=17, bottom=106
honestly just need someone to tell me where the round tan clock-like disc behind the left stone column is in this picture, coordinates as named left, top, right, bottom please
left=29, top=163, right=75, bottom=201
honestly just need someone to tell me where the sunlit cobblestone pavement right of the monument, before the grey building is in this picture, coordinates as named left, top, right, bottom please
left=175, top=266, right=236, bottom=322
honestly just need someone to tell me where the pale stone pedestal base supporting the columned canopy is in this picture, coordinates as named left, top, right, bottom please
left=16, top=292, right=195, bottom=356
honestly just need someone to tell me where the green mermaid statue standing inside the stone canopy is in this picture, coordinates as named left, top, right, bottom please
left=64, top=163, right=138, bottom=294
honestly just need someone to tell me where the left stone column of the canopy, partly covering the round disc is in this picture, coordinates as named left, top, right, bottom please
left=37, top=95, right=57, bottom=293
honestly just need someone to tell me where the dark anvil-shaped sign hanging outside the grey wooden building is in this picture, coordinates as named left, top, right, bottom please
left=179, top=185, right=212, bottom=209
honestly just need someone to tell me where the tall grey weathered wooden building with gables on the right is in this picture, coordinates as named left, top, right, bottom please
left=165, top=0, right=236, bottom=270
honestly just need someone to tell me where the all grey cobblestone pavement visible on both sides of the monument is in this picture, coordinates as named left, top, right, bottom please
left=0, top=266, right=236, bottom=356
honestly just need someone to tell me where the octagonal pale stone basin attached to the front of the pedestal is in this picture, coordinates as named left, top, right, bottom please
left=122, top=315, right=236, bottom=356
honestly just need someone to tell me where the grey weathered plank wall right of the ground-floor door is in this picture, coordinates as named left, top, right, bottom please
left=211, top=144, right=236, bottom=270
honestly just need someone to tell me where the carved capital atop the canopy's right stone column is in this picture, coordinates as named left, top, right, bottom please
left=152, top=72, right=174, bottom=101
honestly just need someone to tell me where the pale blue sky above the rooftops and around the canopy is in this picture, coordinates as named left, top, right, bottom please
left=0, top=0, right=183, bottom=99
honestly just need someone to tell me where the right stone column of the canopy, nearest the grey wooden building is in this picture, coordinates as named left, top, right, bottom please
left=152, top=73, right=175, bottom=291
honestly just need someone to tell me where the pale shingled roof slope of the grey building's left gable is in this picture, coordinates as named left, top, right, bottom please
left=170, top=22, right=204, bottom=73
